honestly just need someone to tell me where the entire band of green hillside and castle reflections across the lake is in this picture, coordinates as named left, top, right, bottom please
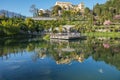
left=0, top=38, right=120, bottom=69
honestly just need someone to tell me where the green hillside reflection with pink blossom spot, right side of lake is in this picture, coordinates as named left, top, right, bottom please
left=88, top=39, right=120, bottom=69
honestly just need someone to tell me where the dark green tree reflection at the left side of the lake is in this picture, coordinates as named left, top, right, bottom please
left=0, top=38, right=42, bottom=59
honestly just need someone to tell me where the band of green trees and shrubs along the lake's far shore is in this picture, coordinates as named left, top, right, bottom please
left=0, top=18, right=120, bottom=37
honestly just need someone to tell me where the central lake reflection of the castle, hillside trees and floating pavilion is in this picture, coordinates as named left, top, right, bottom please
left=32, top=39, right=84, bottom=64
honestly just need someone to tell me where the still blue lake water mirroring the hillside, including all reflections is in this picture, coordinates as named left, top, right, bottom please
left=0, top=37, right=120, bottom=80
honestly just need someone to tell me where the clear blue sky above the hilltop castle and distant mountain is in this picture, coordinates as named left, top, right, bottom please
left=0, top=0, right=106, bottom=16
